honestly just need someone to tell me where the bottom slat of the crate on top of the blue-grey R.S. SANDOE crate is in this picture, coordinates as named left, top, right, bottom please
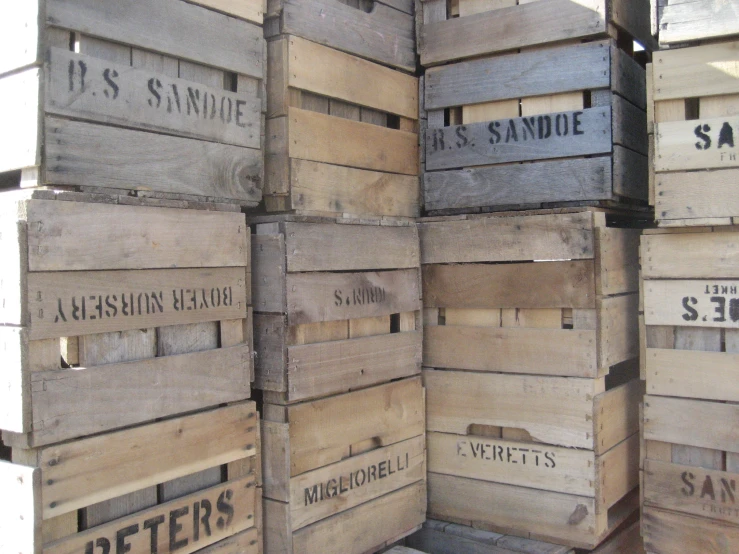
left=420, top=0, right=607, bottom=66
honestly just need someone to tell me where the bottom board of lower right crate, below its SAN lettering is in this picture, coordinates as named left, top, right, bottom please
left=642, top=506, right=739, bottom=554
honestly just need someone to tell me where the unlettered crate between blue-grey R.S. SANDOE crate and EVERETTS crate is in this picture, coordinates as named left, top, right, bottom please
left=419, top=209, right=640, bottom=378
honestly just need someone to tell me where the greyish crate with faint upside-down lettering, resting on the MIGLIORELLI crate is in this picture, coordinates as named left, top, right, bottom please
left=250, top=216, right=422, bottom=404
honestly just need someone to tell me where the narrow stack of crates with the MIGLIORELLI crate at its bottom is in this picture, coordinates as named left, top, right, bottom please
left=256, top=0, right=426, bottom=554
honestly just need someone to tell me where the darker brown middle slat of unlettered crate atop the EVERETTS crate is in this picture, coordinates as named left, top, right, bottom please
left=423, top=260, right=595, bottom=309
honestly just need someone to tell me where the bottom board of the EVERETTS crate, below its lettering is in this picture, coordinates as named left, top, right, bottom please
left=428, top=473, right=639, bottom=549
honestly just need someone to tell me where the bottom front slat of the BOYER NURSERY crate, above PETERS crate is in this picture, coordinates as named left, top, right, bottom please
left=31, top=346, right=251, bottom=446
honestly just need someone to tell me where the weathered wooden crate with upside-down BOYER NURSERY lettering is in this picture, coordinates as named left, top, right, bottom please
left=0, top=191, right=253, bottom=447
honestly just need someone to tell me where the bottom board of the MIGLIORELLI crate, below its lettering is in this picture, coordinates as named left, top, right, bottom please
left=264, top=481, right=426, bottom=554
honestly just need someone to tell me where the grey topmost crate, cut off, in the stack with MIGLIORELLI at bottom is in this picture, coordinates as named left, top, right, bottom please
left=264, top=0, right=416, bottom=73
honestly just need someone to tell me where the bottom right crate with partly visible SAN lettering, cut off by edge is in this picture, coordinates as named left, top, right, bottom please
left=643, top=392, right=739, bottom=554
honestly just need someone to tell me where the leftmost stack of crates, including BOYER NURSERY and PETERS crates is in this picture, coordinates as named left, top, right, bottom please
left=0, top=0, right=266, bottom=554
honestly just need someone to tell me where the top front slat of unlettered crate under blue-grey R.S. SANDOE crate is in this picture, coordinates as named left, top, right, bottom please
left=419, top=212, right=595, bottom=264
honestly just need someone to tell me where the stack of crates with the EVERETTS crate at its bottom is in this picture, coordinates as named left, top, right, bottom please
left=417, top=0, right=651, bottom=549
